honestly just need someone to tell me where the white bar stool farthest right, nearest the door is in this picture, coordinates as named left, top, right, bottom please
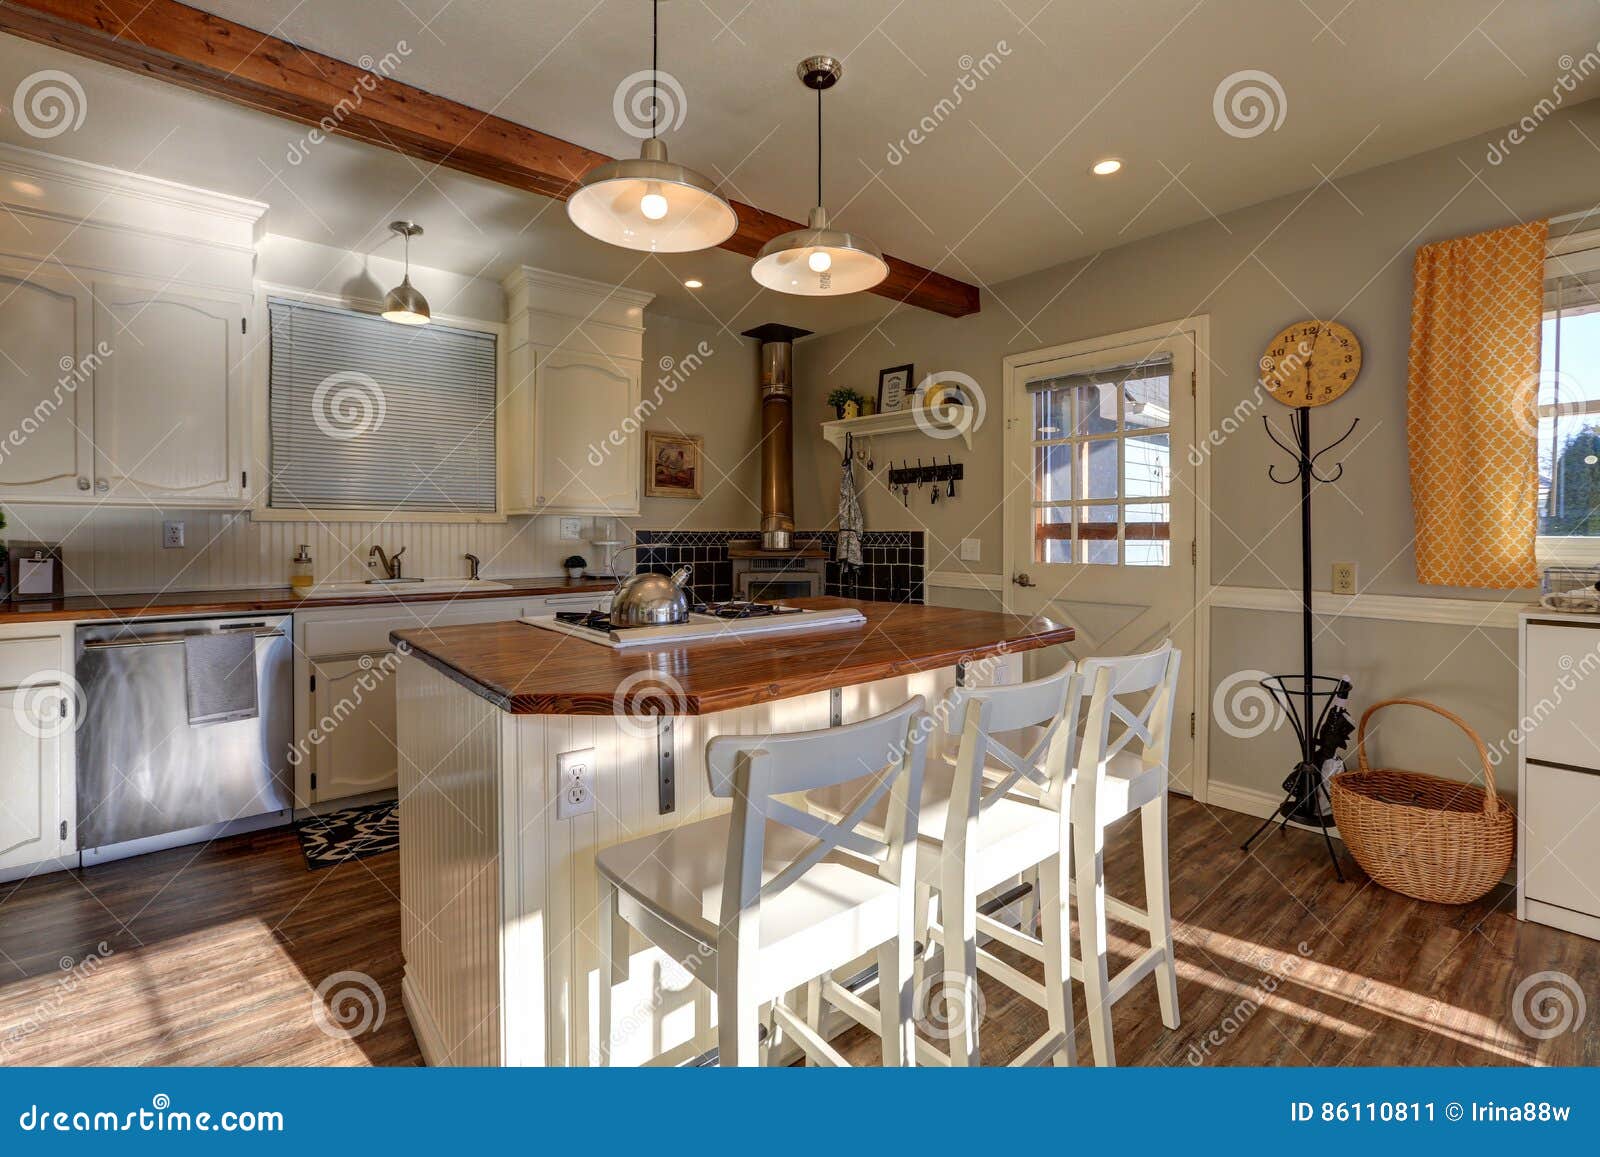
left=1072, top=642, right=1182, bottom=1064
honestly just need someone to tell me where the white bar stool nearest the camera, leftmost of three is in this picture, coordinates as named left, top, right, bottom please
left=595, top=696, right=934, bottom=1066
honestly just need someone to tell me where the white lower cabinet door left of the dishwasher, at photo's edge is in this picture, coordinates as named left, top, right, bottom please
left=0, top=687, right=74, bottom=867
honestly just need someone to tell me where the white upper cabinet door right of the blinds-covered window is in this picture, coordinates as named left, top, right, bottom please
left=534, top=352, right=643, bottom=514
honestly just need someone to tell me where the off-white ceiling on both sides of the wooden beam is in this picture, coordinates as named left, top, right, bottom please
left=0, top=0, right=1600, bottom=330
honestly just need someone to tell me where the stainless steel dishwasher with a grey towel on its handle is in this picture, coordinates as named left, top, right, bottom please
left=75, top=615, right=294, bottom=866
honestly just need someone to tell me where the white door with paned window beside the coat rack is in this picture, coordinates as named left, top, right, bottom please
left=1005, top=328, right=1197, bottom=792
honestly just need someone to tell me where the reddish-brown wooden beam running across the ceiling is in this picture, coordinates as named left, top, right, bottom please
left=0, top=0, right=979, bottom=317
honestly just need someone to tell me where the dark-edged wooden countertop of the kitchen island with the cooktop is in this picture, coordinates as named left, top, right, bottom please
left=392, top=599, right=1072, bottom=715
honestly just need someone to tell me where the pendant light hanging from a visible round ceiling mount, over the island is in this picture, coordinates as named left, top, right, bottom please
left=750, top=56, right=890, bottom=298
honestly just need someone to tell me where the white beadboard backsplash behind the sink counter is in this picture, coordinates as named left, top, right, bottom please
left=0, top=504, right=582, bottom=594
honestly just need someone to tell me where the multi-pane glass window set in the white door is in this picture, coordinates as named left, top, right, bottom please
left=1027, top=360, right=1173, bottom=566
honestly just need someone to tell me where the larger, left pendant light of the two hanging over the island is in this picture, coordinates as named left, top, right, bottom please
left=566, top=0, right=739, bottom=253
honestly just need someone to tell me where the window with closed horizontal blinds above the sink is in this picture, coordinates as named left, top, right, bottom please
left=267, top=298, right=496, bottom=514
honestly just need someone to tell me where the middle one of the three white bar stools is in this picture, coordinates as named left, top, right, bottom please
left=806, top=664, right=1083, bottom=1066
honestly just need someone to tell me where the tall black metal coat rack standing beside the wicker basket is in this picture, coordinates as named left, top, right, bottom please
left=1243, top=406, right=1362, bottom=883
